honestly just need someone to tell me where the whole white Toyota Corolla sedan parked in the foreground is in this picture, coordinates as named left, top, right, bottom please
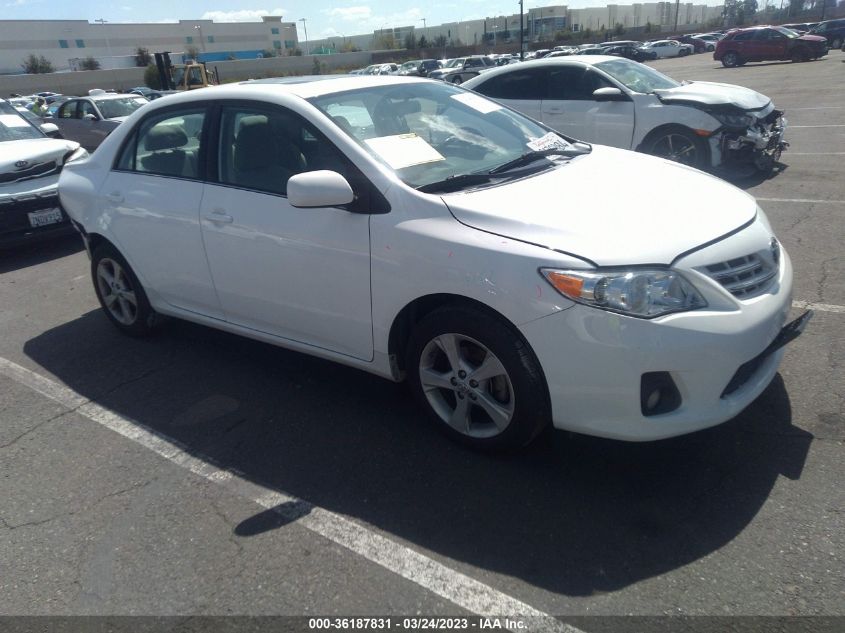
left=60, top=77, right=806, bottom=449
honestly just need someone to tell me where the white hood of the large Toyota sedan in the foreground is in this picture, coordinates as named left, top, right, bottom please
left=442, top=145, right=757, bottom=266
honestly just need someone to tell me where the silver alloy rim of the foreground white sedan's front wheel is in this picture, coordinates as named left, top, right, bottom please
left=419, top=333, right=515, bottom=438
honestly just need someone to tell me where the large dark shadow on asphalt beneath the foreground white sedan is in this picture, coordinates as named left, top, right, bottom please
left=24, top=311, right=812, bottom=596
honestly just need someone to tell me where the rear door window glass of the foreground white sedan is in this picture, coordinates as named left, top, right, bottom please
left=117, top=110, right=205, bottom=179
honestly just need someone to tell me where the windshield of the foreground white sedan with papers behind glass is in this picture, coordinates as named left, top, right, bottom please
left=310, top=82, right=570, bottom=188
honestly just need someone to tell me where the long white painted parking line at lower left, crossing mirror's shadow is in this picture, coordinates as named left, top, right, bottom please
left=0, top=357, right=583, bottom=633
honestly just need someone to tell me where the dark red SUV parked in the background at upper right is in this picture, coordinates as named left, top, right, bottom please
left=713, top=26, right=827, bottom=68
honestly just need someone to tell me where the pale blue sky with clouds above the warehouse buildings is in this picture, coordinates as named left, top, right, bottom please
left=0, top=0, right=723, bottom=40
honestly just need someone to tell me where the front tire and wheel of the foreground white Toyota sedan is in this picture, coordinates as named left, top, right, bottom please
left=406, top=308, right=551, bottom=451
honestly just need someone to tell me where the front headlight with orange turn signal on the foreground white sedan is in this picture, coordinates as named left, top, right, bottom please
left=540, top=268, right=707, bottom=319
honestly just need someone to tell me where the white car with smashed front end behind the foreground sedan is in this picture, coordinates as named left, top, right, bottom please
left=464, top=55, right=787, bottom=174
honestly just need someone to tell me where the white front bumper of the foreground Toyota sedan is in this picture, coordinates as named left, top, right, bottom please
left=520, top=230, right=792, bottom=441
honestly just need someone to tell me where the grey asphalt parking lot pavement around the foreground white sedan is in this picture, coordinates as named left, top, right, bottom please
left=0, top=51, right=845, bottom=631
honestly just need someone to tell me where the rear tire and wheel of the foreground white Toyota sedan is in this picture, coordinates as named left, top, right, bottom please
left=91, top=242, right=156, bottom=337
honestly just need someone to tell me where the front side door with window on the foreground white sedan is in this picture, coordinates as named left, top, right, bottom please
left=200, top=102, right=373, bottom=360
